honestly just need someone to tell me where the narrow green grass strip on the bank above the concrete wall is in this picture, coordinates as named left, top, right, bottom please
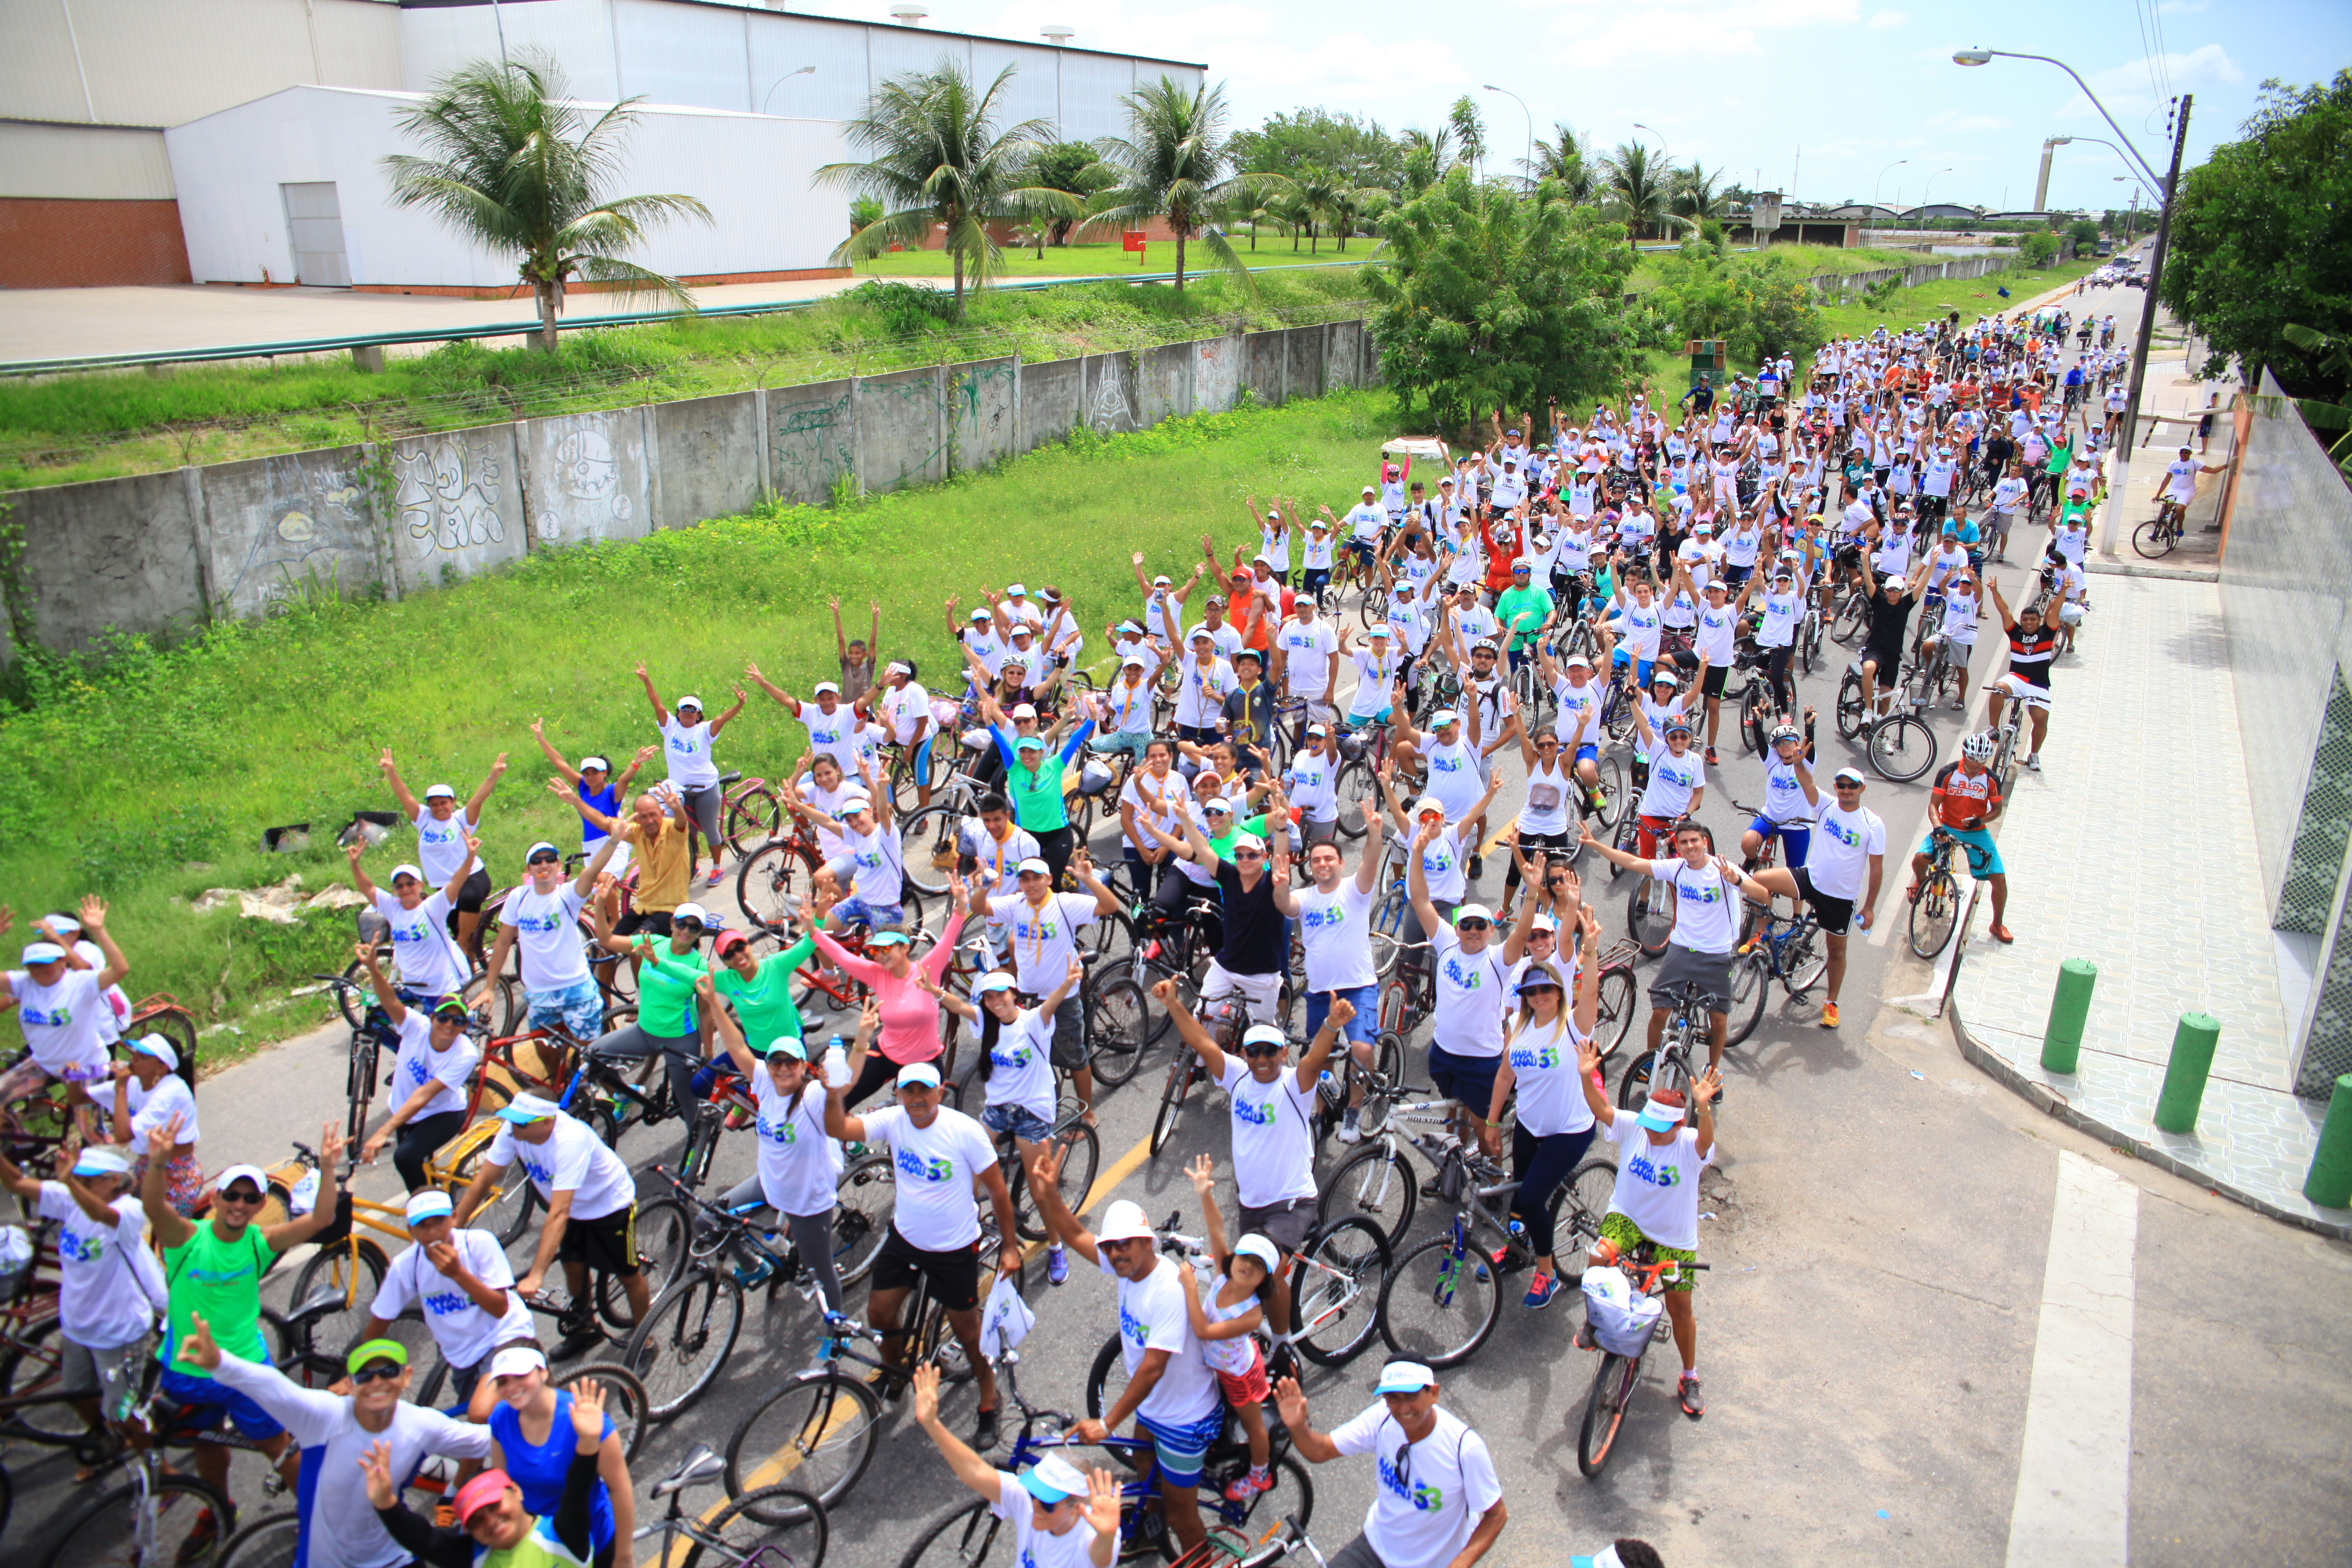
left=0, top=268, right=1364, bottom=489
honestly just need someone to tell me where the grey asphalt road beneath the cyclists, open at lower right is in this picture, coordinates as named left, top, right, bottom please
left=7, top=276, right=2352, bottom=1568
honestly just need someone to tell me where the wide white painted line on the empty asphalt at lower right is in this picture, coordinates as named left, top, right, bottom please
left=2009, top=1152, right=2141, bottom=1568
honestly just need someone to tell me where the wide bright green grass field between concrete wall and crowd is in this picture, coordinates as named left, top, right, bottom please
left=0, top=392, right=1393, bottom=1055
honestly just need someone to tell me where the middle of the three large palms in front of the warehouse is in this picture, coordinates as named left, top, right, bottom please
left=816, top=59, right=1084, bottom=320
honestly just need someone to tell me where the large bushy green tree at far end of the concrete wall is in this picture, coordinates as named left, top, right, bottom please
left=1364, top=167, right=1663, bottom=430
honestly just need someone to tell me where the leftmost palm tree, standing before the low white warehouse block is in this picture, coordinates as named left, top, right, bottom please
left=383, top=57, right=710, bottom=353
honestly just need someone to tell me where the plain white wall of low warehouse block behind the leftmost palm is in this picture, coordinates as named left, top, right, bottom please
left=165, top=83, right=849, bottom=289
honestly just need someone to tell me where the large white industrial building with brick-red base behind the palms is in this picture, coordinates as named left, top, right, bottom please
left=0, top=0, right=1207, bottom=294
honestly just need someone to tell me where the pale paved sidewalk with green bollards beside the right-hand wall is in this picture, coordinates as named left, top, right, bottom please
left=1938, top=576, right=2352, bottom=1239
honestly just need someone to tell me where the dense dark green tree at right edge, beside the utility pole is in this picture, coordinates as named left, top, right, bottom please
left=2159, top=70, right=2352, bottom=402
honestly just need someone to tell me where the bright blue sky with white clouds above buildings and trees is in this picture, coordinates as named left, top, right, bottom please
left=788, top=0, right=2352, bottom=209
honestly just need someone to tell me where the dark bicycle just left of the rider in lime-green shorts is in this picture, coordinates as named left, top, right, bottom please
left=1378, top=1140, right=1616, bottom=1366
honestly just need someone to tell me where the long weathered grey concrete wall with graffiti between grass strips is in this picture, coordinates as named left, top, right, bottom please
left=14, top=322, right=1378, bottom=649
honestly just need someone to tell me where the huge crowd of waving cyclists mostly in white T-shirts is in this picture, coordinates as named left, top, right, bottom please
left=0, top=282, right=2154, bottom=1568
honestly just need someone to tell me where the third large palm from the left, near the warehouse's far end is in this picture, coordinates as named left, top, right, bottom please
left=1087, top=75, right=1289, bottom=294
